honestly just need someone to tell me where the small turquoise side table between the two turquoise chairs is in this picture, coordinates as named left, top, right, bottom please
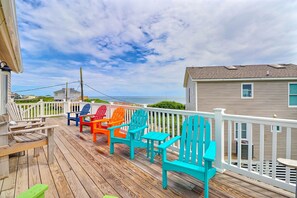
left=142, top=131, right=169, bottom=163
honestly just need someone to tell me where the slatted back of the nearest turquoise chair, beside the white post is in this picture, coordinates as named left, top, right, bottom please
left=179, top=115, right=210, bottom=166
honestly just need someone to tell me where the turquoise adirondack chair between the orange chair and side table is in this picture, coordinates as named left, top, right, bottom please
left=108, top=109, right=147, bottom=159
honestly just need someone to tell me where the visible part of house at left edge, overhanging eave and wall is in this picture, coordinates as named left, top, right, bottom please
left=0, top=0, right=23, bottom=115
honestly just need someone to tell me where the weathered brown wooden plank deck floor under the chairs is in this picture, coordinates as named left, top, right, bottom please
left=0, top=118, right=294, bottom=198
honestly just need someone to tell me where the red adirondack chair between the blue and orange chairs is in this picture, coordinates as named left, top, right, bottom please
left=79, top=105, right=107, bottom=133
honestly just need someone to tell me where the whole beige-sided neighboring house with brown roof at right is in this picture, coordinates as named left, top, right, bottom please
left=184, top=64, right=297, bottom=159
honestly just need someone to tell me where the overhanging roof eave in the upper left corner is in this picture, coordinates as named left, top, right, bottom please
left=0, top=0, right=23, bottom=73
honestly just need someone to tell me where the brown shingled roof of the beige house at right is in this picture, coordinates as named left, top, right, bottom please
left=184, top=64, right=297, bottom=87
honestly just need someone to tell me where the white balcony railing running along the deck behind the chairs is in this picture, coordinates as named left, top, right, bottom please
left=19, top=101, right=297, bottom=192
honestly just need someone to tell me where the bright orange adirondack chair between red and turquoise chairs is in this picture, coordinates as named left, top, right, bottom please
left=92, top=107, right=126, bottom=145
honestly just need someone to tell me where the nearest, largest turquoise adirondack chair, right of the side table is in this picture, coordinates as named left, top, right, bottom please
left=158, top=115, right=216, bottom=198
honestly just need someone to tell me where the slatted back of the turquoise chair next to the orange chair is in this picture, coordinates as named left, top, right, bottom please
left=127, top=109, right=148, bottom=141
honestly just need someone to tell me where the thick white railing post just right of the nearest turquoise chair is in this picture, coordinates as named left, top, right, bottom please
left=214, top=108, right=225, bottom=172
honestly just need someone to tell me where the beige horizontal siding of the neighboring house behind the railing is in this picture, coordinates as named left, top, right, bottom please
left=195, top=81, right=297, bottom=159
